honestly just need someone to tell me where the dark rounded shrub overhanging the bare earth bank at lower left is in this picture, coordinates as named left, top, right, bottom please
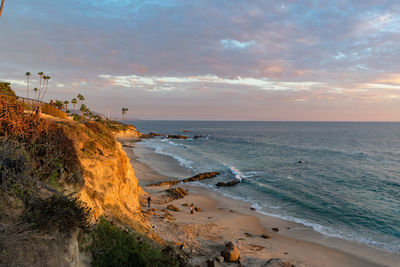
left=24, top=195, right=91, bottom=234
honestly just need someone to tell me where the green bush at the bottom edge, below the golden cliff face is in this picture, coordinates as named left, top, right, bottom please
left=89, top=218, right=179, bottom=267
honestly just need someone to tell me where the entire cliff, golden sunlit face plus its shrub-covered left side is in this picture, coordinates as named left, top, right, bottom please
left=0, top=107, right=164, bottom=266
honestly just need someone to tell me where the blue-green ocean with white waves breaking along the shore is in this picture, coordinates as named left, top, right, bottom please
left=126, top=121, right=400, bottom=254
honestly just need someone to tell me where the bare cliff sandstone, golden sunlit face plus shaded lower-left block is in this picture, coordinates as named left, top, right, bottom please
left=0, top=119, right=156, bottom=266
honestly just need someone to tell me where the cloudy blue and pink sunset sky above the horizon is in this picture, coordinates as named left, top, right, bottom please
left=0, top=0, right=400, bottom=121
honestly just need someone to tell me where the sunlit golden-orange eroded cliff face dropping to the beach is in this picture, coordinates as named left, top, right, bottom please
left=57, top=122, right=153, bottom=236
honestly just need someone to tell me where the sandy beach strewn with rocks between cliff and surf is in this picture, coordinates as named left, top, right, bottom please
left=124, top=141, right=400, bottom=266
